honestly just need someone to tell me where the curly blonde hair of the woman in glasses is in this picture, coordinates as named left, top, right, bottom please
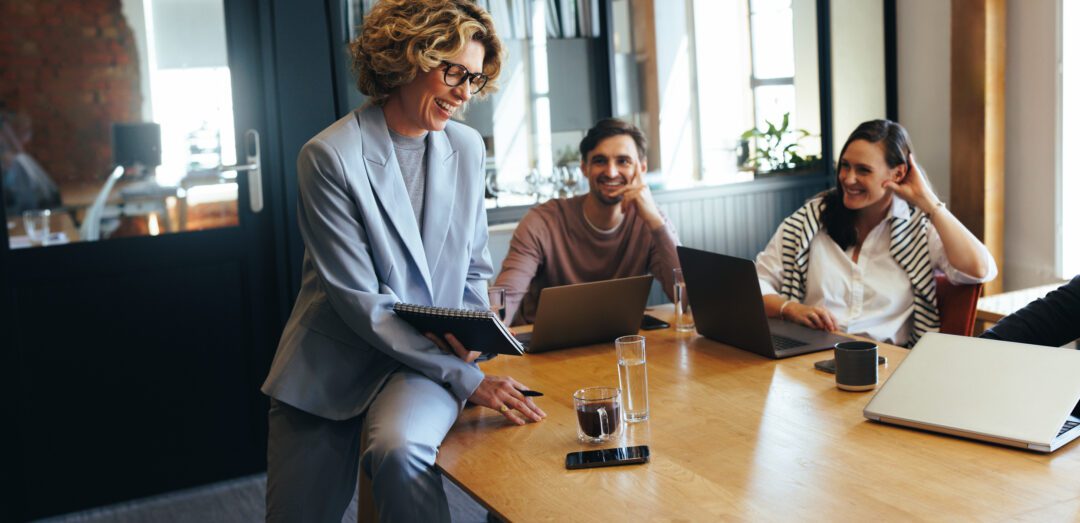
left=349, top=0, right=502, bottom=105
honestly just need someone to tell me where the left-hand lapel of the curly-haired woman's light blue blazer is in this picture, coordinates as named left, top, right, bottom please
left=360, top=106, right=434, bottom=301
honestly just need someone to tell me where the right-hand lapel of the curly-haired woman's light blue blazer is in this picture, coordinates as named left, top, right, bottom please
left=423, top=131, right=458, bottom=272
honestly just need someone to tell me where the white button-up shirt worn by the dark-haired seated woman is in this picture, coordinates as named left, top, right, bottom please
left=756, top=197, right=998, bottom=346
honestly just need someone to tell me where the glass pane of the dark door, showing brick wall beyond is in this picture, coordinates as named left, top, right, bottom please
left=0, top=0, right=239, bottom=251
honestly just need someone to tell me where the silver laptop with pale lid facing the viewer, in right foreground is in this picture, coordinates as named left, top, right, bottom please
left=863, top=333, right=1080, bottom=452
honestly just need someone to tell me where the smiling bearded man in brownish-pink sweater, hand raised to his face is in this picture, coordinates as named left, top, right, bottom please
left=495, top=119, right=678, bottom=324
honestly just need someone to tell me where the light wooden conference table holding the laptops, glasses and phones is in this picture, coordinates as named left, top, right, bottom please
left=437, top=307, right=1080, bottom=521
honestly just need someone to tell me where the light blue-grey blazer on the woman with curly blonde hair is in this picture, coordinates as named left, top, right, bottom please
left=262, top=106, right=492, bottom=419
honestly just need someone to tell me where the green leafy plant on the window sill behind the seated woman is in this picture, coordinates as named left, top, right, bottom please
left=740, top=112, right=821, bottom=174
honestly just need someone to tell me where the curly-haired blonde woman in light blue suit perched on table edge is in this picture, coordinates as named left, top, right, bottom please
left=262, top=0, right=544, bottom=522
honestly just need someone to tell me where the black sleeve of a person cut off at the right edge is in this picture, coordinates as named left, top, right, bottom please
left=980, top=276, right=1080, bottom=347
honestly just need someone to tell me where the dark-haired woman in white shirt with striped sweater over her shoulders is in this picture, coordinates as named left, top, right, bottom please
left=757, top=120, right=997, bottom=346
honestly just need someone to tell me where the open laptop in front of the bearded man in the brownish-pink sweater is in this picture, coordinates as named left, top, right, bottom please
left=517, top=276, right=652, bottom=352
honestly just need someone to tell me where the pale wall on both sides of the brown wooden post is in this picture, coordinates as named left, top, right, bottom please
left=896, top=0, right=1057, bottom=291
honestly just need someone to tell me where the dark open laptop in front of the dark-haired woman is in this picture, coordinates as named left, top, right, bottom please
left=678, top=246, right=851, bottom=358
